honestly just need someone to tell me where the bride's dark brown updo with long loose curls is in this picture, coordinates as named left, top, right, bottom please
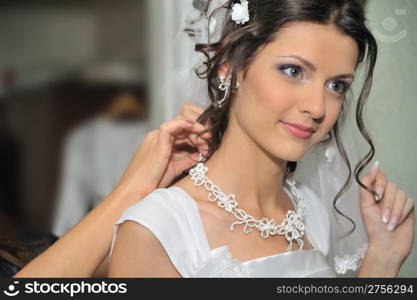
left=195, top=0, right=378, bottom=239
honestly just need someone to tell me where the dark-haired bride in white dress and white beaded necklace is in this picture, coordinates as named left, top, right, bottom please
left=108, top=0, right=415, bottom=277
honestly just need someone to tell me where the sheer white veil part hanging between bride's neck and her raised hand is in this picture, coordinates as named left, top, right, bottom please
left=293, top=122, right=368, bottom=277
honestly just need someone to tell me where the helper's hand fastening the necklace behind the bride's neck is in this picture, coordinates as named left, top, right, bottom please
left=118, top=104, right=211, bottom=195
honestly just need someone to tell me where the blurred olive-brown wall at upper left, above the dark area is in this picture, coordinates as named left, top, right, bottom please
left=0, top=0, right=147, bottom=95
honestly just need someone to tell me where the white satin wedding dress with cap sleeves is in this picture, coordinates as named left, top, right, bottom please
left=110, top=182, right=336, bottom=277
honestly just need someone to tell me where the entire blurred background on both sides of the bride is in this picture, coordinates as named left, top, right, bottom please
left=0, top=0, right=417, bottom=277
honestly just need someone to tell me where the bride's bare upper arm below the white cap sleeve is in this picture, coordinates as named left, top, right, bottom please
left=107, top=221, right=181, bottom=278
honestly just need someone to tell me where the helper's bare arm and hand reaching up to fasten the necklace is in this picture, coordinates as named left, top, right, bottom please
left=14, top=105, right=209, bottom=278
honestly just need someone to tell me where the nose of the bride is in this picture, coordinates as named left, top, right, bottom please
left=298, top=84, right=326, bottom=119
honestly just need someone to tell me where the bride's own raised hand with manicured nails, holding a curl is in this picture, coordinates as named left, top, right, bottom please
left=360, top=162, right=415, bottom=264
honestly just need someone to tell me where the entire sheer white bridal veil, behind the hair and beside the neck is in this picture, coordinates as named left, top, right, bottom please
left=176, top=0, right=368, bottom=277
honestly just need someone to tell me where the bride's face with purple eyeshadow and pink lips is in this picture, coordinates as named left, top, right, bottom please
left=230, top=22, right=358, bottom=161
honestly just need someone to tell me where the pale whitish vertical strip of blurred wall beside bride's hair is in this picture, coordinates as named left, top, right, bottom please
left=147, top=0, right=195, bottom=128
